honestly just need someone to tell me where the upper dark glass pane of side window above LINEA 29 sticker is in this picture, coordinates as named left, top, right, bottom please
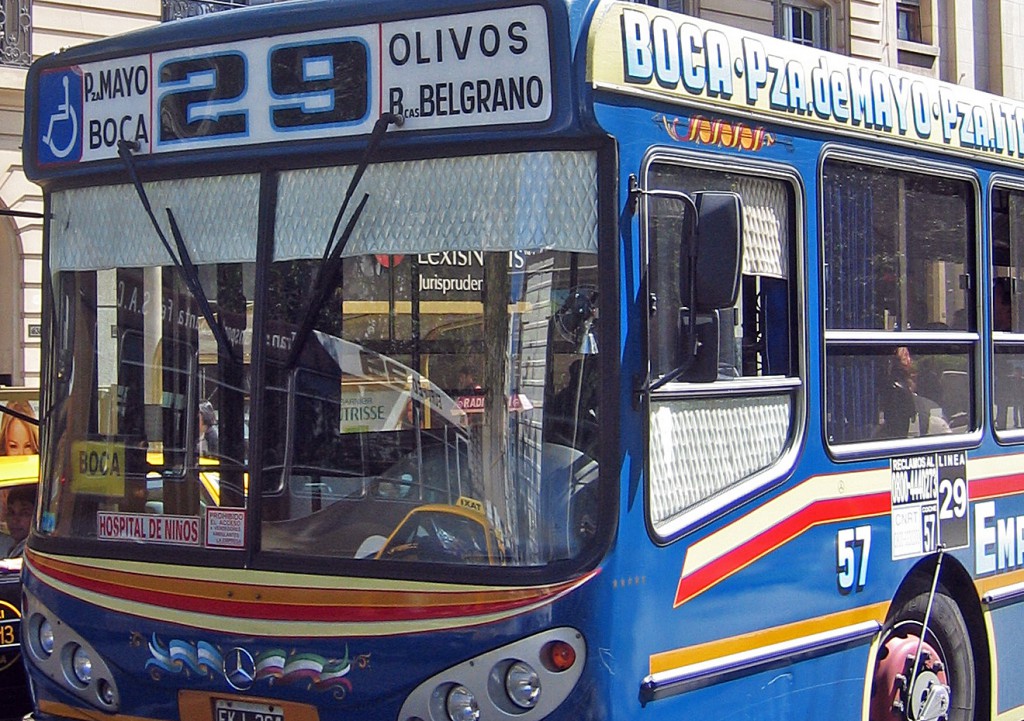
left=822, top=162, right=974, bottom=331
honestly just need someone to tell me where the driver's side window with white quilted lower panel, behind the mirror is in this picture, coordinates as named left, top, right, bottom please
left=645, top=157, right=801, bottom=536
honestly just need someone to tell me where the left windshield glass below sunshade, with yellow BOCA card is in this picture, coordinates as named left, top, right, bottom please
left=40, top=263, right=254, bottom=547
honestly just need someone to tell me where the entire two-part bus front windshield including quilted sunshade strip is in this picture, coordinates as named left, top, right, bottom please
left=40, top=153, right=599, bottom=572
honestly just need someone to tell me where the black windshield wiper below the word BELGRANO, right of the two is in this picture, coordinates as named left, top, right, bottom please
left=285, top=113, right=406, bottom=369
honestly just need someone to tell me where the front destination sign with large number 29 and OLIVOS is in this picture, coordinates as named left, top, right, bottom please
left=36, top=5, right=553, bottom=167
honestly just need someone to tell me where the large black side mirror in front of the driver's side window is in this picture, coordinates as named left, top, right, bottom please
left=679, top=192, right=743, bottom=312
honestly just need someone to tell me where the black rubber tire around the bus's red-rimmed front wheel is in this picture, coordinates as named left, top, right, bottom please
left=871, top=584, right=977, bottom=721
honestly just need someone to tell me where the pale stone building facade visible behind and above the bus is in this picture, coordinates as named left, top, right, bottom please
left=0, top=0, right=1024, bottom=387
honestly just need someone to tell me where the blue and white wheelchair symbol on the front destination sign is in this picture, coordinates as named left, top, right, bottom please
left=39, top=71, right=82, bottom=164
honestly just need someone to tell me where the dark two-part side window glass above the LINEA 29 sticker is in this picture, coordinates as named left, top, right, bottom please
left=822, top=158, right=978, bottom=448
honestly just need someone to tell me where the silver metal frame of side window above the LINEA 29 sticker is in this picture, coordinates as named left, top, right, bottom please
left=816, top=145, right=987, bottom=461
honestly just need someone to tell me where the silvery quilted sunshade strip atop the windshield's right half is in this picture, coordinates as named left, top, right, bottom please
left=274, top=152, right=597, bottom=263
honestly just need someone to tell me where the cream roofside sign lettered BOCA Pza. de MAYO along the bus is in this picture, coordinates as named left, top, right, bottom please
left=588, top=3, right=1024, bottom=160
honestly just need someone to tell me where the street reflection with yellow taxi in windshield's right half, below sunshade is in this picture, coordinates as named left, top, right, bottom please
left=262, top=251, right=599, bottom=565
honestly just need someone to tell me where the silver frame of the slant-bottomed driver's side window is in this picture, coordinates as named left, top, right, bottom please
left=638, top=147, right=809, bottom=544
